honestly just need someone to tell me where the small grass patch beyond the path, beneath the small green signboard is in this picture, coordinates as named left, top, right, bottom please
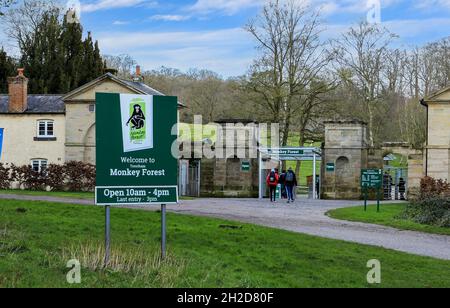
left=328, top=204, right=450, bottom=235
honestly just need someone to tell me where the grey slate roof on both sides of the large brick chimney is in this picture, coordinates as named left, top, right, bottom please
left=0, top=94, right=66, bottom=114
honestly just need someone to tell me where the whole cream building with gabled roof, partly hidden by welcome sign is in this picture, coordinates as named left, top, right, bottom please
left=0, top=68, right=183, bottom=169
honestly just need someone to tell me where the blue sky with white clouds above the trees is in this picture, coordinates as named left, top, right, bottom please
left=2, top=0, right=450, bottom=77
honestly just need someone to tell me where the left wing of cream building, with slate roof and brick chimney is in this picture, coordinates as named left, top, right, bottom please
left=0, top=70, right=66, bottom=171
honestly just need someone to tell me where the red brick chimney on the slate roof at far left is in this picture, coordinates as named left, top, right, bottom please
left=8, top=68, right=28, bottom=113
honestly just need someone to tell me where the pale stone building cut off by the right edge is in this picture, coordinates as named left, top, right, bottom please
left=422, top=87, right=450, bottom=180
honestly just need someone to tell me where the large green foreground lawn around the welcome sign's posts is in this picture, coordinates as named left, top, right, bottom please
left=0, top=200, right=450, bottom=287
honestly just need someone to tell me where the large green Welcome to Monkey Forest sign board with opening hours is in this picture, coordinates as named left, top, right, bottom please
left=95, top=93, right=178, bottom=205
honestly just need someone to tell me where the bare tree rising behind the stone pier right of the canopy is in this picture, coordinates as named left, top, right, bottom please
left=337, top=22, right=395, bottom=146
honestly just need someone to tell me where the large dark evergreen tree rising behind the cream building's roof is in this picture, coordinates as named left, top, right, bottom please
left=21, top=9, right=104, bottom=94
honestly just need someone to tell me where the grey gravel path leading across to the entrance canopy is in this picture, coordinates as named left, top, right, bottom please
left=0, top=195, right=450, bottom=260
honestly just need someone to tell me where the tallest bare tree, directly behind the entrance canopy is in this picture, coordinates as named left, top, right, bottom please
left=246, top=0, right=333, bottom=146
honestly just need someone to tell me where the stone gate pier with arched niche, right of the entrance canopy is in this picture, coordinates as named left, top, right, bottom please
left=321, top=120, right=383, bottom=199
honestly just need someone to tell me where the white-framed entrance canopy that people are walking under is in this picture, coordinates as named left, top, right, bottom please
left=259, top=147, right=322, bottom=199
